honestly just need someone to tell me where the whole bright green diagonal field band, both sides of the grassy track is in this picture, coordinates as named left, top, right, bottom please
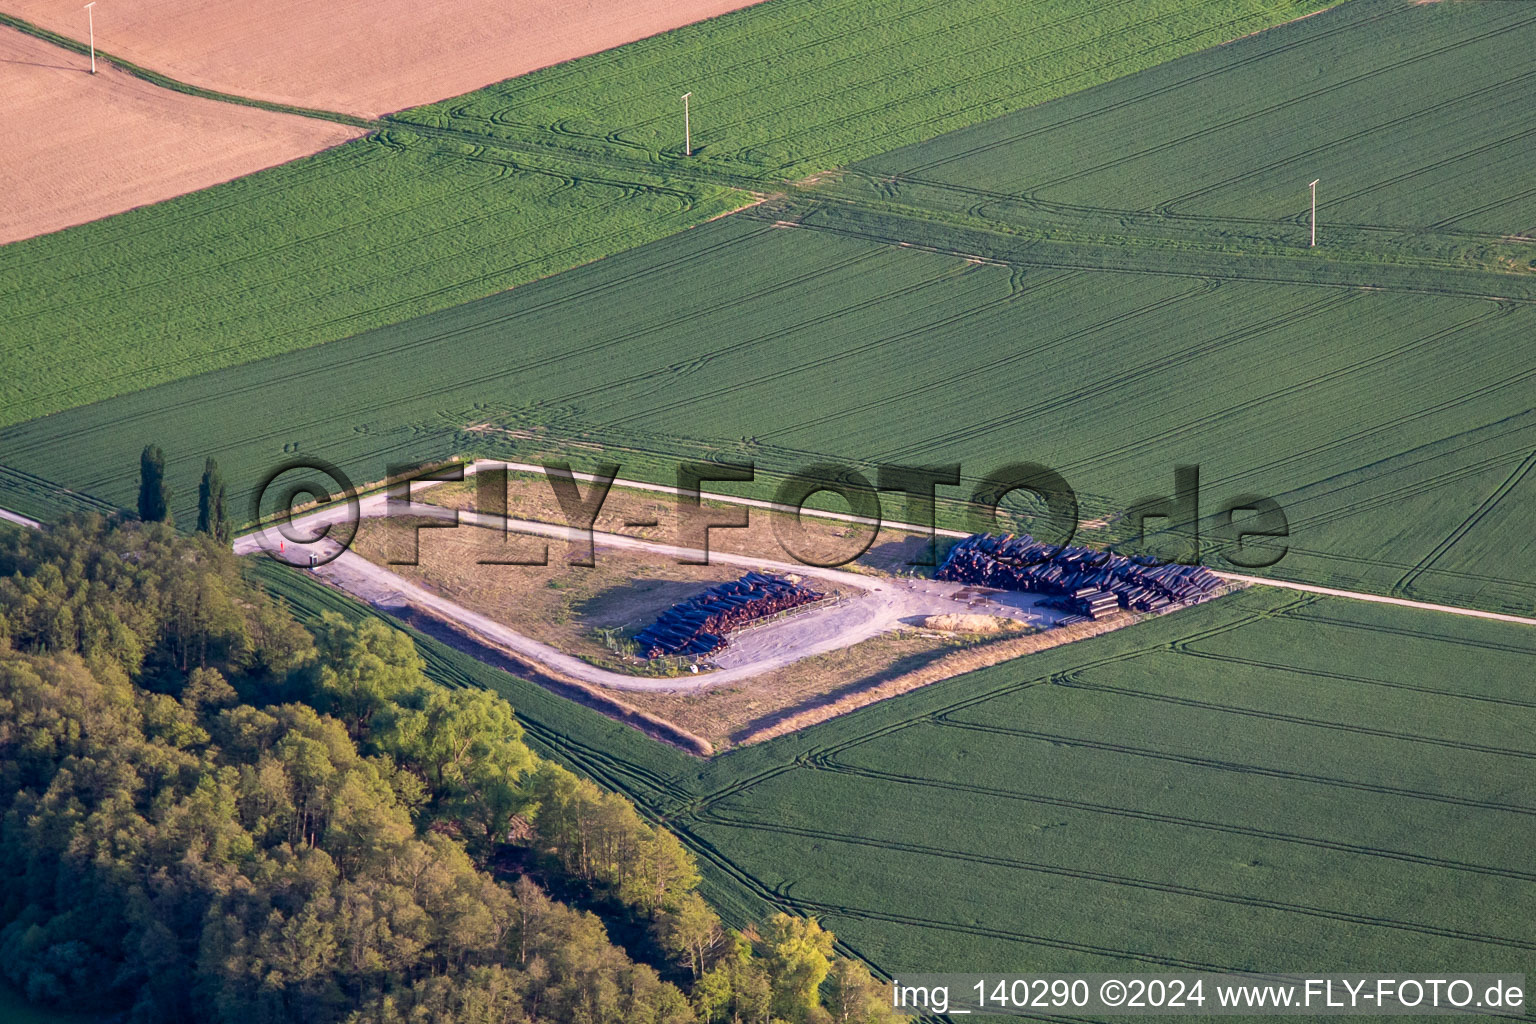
left=0, top=0, right=1326, bottom=425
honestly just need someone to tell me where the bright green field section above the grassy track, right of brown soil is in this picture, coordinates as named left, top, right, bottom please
left=392, top=0, right=1336, bottom=184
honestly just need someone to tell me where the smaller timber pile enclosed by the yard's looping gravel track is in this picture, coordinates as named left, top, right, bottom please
left=634, top=573, right=826, bottom=657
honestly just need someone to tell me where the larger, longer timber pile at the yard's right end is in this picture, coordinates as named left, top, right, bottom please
left=935, top=533, right=1221, bottom=619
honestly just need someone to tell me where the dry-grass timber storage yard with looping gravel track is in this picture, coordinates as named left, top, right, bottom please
left=282, top=474, right=1155, bottom=749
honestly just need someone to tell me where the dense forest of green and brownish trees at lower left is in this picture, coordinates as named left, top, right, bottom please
left=0, top=519, right=900, bottom=1024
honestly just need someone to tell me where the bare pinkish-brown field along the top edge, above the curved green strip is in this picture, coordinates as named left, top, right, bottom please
left=5, top=0, right=768, bottom=117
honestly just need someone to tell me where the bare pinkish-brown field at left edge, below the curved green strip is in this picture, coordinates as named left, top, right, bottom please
left=0, top=28, right=361, bottom=244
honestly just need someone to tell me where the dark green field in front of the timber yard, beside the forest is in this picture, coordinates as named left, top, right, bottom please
left=266, top=570, right=1536, bottom=973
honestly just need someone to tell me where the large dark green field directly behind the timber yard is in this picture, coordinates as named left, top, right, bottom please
left=0, top=216, right=1536, bottom=613
